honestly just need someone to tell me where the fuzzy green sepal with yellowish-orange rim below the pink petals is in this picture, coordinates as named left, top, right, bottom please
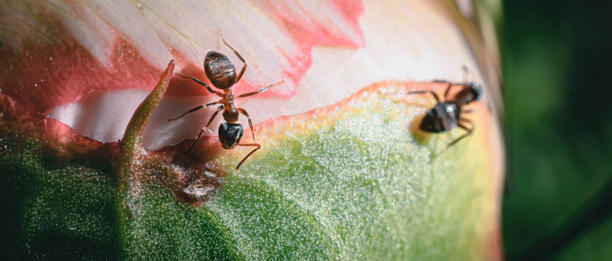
left=0, top=82, right=500, bottom=260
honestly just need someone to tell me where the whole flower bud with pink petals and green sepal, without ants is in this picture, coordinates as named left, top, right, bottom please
left=0, top=1, right=503, bottom=260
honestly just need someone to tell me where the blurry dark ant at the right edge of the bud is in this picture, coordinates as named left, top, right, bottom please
left=408, top=77, right=482, bottom=148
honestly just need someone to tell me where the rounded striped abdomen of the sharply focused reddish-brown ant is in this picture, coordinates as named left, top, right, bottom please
left=204, top=51, right=236, bottom=89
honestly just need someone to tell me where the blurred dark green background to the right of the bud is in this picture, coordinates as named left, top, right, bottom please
left=500, top=0, right=612, bottom=260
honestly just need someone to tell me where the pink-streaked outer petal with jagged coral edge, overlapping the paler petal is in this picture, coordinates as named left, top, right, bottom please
left=0, top=0, right=362, bottom=113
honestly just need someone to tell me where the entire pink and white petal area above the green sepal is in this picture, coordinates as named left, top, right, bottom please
left=0, top=0, right=490, bottom=150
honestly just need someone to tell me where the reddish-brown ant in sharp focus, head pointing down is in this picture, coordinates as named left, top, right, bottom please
left=168, top=34, right=284, bottom=170
